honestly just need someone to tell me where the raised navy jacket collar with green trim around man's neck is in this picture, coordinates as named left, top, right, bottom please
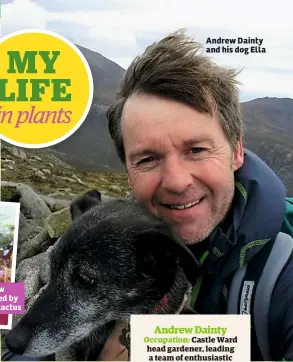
left=205, top=149, right=286, bottom=278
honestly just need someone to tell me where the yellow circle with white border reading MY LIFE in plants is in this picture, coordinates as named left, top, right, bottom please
left=0, top=30, right=93, bottom=148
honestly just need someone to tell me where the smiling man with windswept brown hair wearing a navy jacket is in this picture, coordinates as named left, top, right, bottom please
left=107, top=31, right=293, bottom=360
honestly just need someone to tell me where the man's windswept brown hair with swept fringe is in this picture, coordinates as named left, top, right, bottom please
left=107, top=30, right=243, bottom=164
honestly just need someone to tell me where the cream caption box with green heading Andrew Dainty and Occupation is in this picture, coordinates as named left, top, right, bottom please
left=130, top=315, right=250, bottom=362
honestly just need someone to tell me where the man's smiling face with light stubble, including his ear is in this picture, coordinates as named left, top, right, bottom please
left=121, top=94, right=243, bottom=244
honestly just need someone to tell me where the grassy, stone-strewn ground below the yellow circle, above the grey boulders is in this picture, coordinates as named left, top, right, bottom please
left=1, top=141, right=129, bottom=200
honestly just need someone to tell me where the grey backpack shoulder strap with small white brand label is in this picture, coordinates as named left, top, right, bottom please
left=227, top=232, right=293, bottom=361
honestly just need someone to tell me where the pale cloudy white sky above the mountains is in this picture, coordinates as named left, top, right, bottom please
left=1, top=0, right=293, bottom=101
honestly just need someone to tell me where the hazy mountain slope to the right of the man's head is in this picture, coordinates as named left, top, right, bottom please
left=242, top=98, right=293, bottom=195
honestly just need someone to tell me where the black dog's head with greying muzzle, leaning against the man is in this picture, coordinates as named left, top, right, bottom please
left=7, top=192, right=197, bottom=355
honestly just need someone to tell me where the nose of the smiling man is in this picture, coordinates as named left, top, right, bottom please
left=162, top=159, right=193, bottom=194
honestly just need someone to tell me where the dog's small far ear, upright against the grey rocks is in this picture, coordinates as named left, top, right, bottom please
left=70, top=190, right=101, bottom=220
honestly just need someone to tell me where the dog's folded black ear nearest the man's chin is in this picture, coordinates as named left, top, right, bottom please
left=137, top=230, right=199, bottom=284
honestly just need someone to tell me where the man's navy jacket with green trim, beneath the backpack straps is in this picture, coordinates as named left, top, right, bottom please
left=191, top=150, right=293, bottom=361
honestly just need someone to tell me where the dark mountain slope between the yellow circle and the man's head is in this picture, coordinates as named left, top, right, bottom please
left=51, top=46, right=124, bottom=171
